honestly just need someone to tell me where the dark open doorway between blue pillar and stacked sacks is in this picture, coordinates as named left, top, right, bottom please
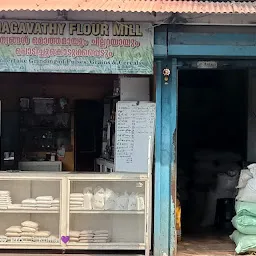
left=177, top=70, right=248, bottom=256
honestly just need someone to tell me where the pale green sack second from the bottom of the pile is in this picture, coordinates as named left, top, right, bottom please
left=232, top=215, right=256, bottom=235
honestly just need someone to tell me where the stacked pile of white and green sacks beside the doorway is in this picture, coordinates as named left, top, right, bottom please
left=230, top=164, right=256, bottom=254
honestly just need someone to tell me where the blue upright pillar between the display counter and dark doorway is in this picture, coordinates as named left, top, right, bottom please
left=154, top=59, right=177, bottom=256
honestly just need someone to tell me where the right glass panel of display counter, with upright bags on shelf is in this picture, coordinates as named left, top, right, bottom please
left=69, top=180, right=146, bottom=247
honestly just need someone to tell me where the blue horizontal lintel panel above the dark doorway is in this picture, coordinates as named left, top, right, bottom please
left=168, top=29, right=256, bottom=58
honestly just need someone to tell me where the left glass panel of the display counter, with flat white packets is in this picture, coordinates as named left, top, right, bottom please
left=0, top=179, right=60, bottom=246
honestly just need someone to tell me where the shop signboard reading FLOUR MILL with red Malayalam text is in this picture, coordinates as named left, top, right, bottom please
left=0, top=20, right=154, bottom=74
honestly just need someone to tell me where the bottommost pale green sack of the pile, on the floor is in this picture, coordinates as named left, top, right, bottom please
left=230, top=230, right=256, bottom=254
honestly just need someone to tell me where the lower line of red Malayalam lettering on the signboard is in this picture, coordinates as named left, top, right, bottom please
left=16, top=48, right=114, bottom=58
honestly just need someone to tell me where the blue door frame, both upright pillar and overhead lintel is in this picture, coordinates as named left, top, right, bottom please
left=154, top=27, right=256, bottom=256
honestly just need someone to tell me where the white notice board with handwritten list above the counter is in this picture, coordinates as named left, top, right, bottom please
left=115, top=101, right=156, bottom=173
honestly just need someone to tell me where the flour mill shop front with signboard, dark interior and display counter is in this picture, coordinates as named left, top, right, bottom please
left=0, top=15, right=155, bottom=255
